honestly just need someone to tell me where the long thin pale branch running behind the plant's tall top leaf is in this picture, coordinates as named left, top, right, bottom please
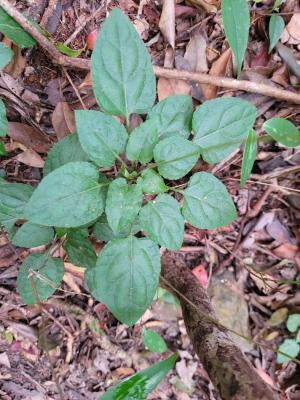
left=0, top=0, right=300, bottom=104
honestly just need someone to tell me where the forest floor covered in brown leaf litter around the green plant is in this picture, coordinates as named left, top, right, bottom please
left=0, top=0, right=300, bottom=400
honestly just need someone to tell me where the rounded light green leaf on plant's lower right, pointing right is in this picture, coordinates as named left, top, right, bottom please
left=182, top=172, right=237, bottom=229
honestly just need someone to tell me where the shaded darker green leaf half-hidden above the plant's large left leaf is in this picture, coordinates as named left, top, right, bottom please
left=44, top=133, right=89, bottom=176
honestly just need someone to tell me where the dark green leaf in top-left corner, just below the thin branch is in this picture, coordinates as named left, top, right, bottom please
left=0, top=7, right=36, bottom=49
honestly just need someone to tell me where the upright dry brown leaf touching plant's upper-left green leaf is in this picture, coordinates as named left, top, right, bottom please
left=51, top=101, right=76, bottom=140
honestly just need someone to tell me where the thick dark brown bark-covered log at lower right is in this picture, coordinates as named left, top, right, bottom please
left=161, top=252, right=279, bottom=400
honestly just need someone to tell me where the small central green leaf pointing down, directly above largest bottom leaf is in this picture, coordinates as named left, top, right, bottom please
left=105, top=178, right=143, bottom=234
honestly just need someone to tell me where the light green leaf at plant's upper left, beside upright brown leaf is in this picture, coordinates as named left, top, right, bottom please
left=75, top=110, right=128, bottom=167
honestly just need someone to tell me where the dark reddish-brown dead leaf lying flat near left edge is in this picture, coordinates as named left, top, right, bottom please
left=8, top=122, right=51, bottom=153
